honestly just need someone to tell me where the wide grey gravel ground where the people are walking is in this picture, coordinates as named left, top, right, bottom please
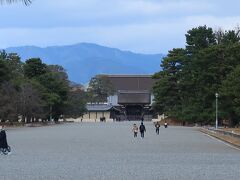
left=0, top=122, right=240, bottom=180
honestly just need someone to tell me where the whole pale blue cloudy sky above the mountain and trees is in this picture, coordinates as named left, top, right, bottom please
left=0, top=0, right=240, bottom=53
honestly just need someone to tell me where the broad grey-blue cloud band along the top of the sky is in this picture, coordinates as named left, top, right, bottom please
left=0, top=0, right=227, bottom=28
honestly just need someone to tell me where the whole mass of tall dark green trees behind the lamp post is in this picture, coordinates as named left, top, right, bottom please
left=153, top=26, right=240, bottom=126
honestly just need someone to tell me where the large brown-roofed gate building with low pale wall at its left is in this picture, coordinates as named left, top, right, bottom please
left=83, top=75, right=156, bottom=121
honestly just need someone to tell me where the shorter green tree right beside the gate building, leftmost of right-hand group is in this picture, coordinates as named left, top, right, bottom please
left=153, top=49, right=187, bottom=118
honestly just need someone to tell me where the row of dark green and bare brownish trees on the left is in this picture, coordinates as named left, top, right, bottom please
left=0, top=51, right=88, bottom=123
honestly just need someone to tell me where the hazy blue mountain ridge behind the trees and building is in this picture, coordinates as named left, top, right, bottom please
left=6, top=43, right=163, bottom=84
